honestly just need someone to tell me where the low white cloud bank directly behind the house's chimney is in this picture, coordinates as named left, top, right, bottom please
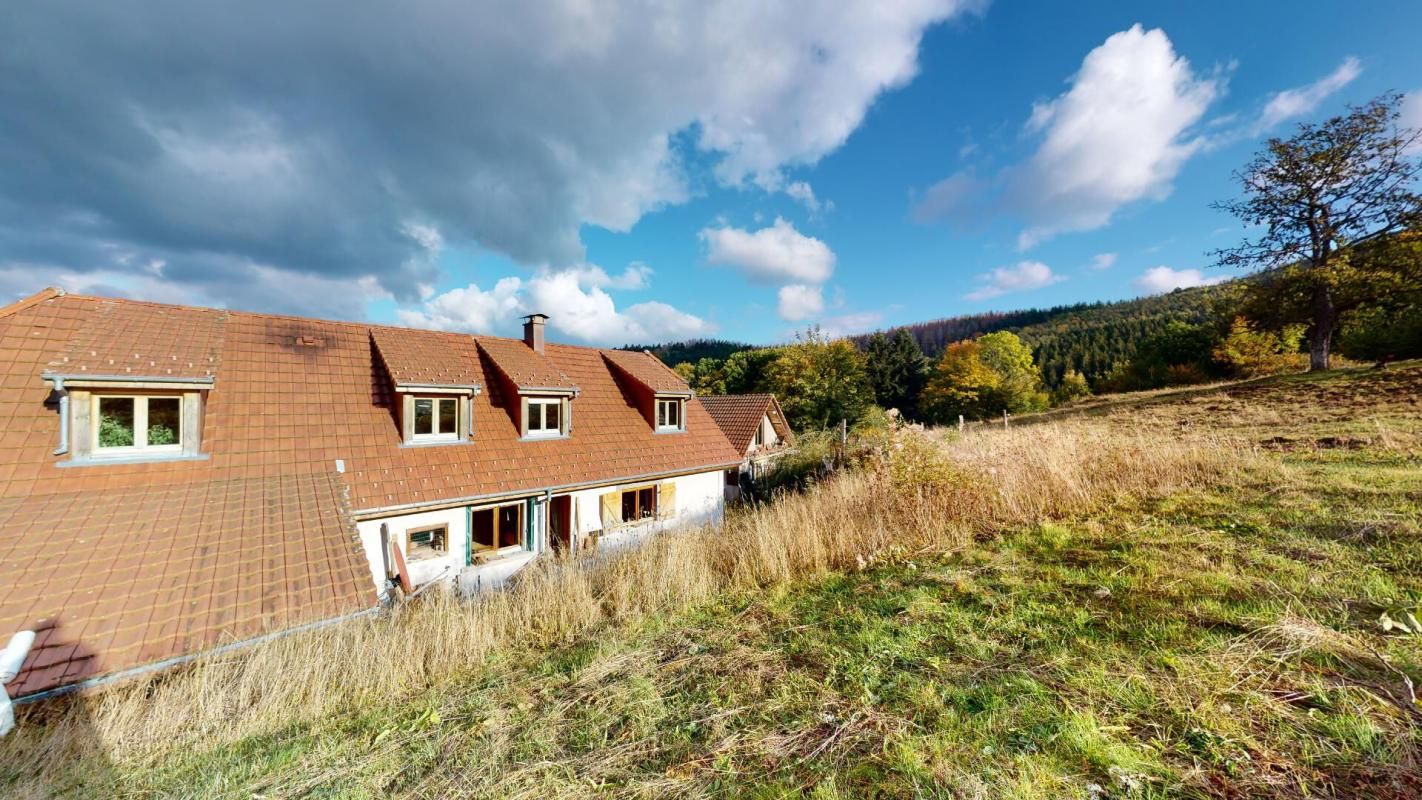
left=397, top=264, right=715, bottom=345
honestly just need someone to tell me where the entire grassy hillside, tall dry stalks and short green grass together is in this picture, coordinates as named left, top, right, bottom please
left=0, top=364, right=1422, bottom=799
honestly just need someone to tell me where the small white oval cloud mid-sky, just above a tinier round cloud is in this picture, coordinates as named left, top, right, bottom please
left=698, top=217, right=835, bottom=284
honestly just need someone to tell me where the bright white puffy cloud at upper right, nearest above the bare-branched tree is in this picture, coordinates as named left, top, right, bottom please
left=914, top=26, right=1223, bottom=249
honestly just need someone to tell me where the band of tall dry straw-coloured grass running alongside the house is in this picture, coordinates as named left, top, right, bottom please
left=0, top=421, right=1247, bottom=790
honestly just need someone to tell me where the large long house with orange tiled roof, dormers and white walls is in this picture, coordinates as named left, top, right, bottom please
left=0, top=288, right=744, bottom=695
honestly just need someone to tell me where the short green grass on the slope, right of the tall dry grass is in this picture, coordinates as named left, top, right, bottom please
left=11, top=366, right=1422, bottom=799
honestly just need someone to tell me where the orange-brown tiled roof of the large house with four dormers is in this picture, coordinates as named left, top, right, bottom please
left=0, top=288, right=742, bottom=693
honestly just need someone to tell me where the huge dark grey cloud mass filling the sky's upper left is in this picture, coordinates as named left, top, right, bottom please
left=0, top=0, right=978, bottom=318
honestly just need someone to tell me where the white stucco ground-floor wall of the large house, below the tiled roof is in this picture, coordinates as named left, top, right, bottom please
left=356, top=470, right=725, bottom=591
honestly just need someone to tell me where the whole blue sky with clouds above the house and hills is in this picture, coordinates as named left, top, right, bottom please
left=8, top=0, right=1422, bottom=344
